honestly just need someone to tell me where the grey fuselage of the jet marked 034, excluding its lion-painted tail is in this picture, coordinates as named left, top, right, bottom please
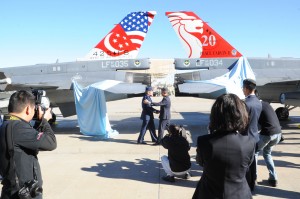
left=175, top=58, right=300, bottom=102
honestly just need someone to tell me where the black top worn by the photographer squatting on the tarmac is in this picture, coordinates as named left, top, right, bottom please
left=161, top=135, right=191, bottom=172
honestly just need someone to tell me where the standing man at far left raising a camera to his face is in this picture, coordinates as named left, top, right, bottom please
left=0, top=90, right=57, bottom=199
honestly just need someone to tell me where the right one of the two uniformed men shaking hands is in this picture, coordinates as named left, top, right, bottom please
left=151, top=88, right=171, bottom=145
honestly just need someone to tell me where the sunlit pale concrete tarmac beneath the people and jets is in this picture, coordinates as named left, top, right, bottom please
left=0, top=97, right=300, bottom=199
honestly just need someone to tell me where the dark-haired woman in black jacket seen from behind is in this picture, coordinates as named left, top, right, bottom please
left=193, top=94, right=255, bottom=199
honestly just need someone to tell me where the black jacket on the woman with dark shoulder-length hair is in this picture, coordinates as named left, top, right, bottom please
left=193, top=132, right=255, bottom=199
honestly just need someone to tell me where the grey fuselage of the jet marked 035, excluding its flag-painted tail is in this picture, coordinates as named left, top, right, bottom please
left=0, top=59, right=150, bottom=116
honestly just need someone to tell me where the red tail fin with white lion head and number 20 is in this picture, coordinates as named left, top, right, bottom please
left=166, top=11, right=242, bottom=58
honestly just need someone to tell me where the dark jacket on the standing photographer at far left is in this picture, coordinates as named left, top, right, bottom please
left=0, top=116, right=57, bottom=195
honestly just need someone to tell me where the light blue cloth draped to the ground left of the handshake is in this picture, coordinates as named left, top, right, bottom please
left=73, top=81, right=119, bottom=139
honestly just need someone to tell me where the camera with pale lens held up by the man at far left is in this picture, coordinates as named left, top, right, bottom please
left=32, top=89, right=50, bottom=120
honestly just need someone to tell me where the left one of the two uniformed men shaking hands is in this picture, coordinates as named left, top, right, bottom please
left=137, top=86, right=159, bottom=144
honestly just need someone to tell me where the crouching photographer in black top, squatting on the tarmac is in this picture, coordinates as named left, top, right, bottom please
left=161, top=124, right=192, bottom=182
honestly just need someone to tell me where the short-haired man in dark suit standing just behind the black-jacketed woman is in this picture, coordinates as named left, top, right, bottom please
left=243, top=79, right=262, bottom=191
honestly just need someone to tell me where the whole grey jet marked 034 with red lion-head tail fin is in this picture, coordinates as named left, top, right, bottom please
left=166, top=11, right=300, bottom=119
